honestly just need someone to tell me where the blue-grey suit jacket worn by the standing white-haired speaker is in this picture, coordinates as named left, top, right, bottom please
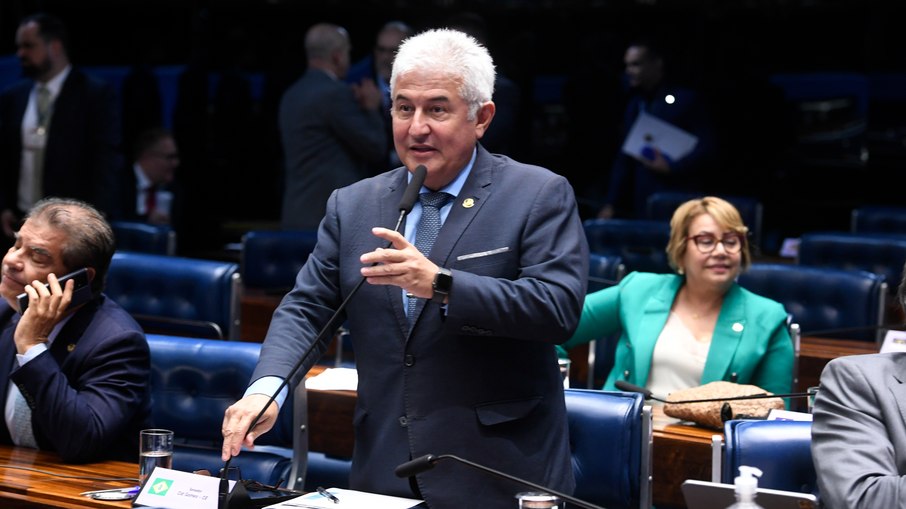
left=253, top=147, right=588, bottom=509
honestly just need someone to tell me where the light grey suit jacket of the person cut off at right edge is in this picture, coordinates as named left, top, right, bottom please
left=812, top=352, right=906, bottom=509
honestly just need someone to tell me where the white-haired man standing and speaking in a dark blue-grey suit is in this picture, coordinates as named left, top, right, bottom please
left=222, top=29, right=588, bottom=509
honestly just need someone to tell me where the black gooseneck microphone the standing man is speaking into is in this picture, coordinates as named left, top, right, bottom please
left=217, top=164, right=428, bottom=509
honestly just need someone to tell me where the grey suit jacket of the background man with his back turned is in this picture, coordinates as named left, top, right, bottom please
left=279, top=69, right=387, bottom=230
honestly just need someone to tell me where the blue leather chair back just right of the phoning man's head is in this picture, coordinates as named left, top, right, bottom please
left=105, top=251, right=242, bottom=340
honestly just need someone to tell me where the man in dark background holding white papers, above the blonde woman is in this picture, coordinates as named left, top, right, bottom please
left=598, top=38, right=716, bottom=219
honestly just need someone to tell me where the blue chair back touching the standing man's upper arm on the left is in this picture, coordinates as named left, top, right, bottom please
left=239, top=230, right=318, bottom=292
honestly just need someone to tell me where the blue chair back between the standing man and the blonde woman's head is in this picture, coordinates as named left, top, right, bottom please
left=583, top=219, right=673, bottom=273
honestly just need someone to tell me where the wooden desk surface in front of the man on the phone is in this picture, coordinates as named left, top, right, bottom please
left=0, top=445, right=138, bottom=509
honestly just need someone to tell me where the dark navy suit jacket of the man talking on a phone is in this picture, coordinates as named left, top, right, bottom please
left=0, top=296, right=151, bottom=462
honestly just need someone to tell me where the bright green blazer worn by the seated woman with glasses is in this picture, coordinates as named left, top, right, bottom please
left=563, top=272, right=793, bottom=394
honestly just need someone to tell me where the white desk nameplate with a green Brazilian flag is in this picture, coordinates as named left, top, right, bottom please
left=132, top=467, right=236, bottom=509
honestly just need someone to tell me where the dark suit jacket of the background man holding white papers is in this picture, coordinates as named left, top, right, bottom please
left=605, top=85, right=717, bottom=218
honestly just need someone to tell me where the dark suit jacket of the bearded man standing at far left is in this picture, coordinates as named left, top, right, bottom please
left=0, top=68, right=123, bottom=216
